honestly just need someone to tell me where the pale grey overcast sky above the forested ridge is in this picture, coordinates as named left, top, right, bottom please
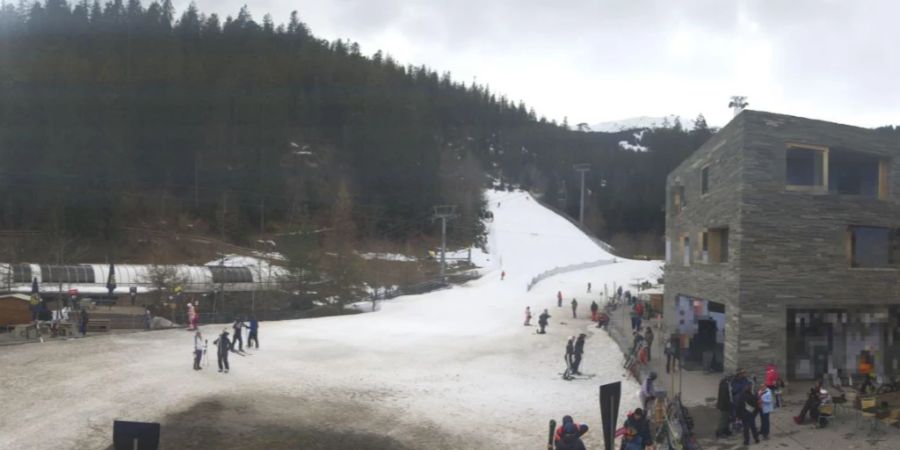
left=176, top=0, right=900, bottom=126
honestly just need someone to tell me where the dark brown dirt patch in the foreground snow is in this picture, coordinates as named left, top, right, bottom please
left=108, top=394, right=460, bottom=450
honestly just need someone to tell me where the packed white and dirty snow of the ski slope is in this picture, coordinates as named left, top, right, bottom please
left=0, top=191, right=659, bottom=450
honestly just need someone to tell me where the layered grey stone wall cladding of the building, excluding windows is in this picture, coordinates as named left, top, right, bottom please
left=665, top=111, right=900, bottom=378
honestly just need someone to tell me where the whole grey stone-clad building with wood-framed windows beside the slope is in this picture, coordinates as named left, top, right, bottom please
left=664, top=111, right=900, bottom=379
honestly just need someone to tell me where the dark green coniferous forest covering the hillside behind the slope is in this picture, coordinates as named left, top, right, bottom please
left=0, top=0, right=711, bottom=260
